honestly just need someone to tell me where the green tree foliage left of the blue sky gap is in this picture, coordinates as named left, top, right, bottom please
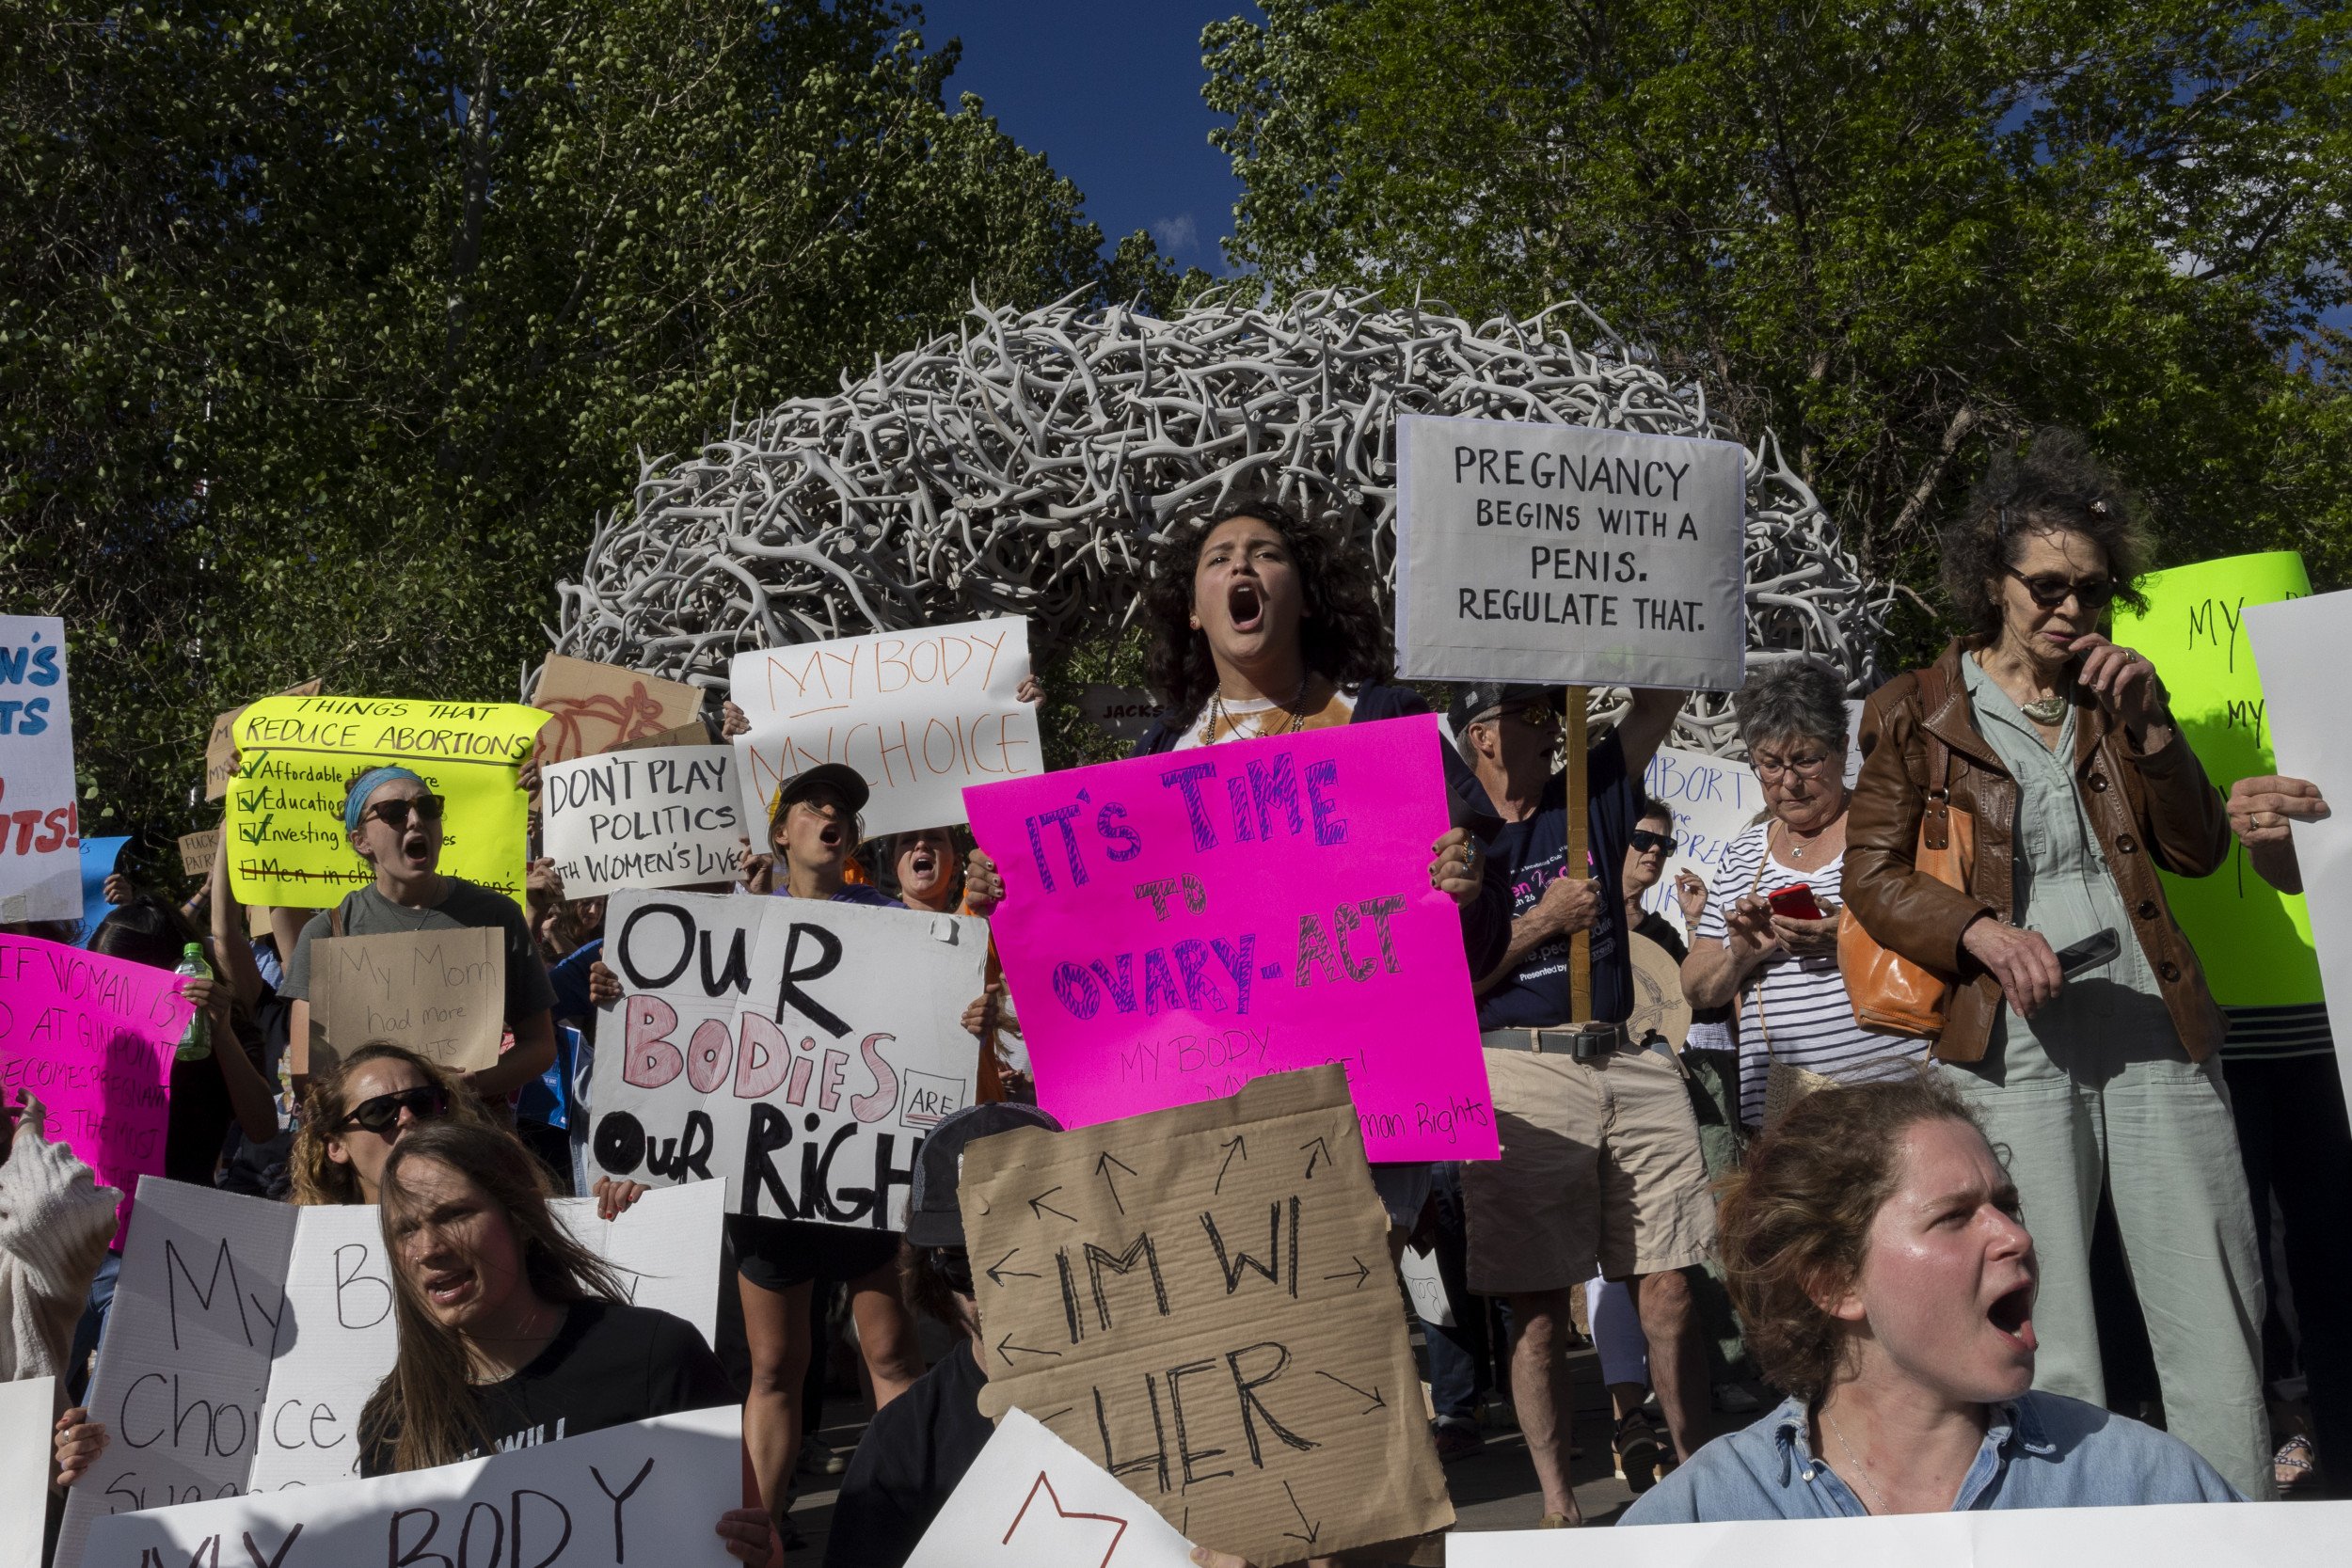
left=0, top=0, right=1181, bottom=864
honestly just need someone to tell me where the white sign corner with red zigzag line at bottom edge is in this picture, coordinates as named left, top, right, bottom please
left=906, top=1411, right=1193, bottom=1568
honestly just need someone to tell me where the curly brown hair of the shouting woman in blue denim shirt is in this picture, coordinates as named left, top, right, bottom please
left=1717, top=1074, right=1985, bottom=1403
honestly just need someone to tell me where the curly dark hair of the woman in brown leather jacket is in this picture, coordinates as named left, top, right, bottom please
left=1941, top=428, right=2148, bottom=637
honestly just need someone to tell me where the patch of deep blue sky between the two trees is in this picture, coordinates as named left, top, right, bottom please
left=922, top=0, right=1259, bottom=273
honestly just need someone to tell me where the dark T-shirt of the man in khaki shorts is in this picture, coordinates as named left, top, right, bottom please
left=1470, top=729, right=1640, bottom=1030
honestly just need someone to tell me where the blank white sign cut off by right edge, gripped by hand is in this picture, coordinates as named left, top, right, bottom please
left=2230, top=593, right=2352, bottom=1114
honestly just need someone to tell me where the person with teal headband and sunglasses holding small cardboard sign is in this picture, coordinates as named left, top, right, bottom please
left=278, top=767, right=555, bottom=1098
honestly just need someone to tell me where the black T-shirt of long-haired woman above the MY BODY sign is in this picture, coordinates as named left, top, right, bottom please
left=360, top=1300, right=739, bottom=1477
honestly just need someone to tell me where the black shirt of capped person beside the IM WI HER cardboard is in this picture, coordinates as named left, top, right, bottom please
left=826, top=1340, right=995, bottom=1568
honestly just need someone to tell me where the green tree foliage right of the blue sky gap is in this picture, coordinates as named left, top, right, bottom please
left=1202, top=0, right=2352, bottom=637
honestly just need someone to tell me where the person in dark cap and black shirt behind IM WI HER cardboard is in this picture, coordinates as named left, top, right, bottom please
left=826, top=1102, right=1061, bottom=1568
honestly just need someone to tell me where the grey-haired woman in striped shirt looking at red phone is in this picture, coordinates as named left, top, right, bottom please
left=1682, top=658, right=1924, bottom=1126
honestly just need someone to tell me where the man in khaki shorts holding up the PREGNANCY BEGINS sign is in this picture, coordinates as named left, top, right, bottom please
left=1449, top=684, right=1715, bottom=1526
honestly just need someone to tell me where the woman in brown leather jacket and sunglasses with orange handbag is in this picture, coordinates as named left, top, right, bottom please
left=1844, top=433, right=2275, bottom=1497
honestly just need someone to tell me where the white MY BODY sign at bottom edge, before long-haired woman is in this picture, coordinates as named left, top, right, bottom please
left=80, top=1406, right=743, bottom=1568
